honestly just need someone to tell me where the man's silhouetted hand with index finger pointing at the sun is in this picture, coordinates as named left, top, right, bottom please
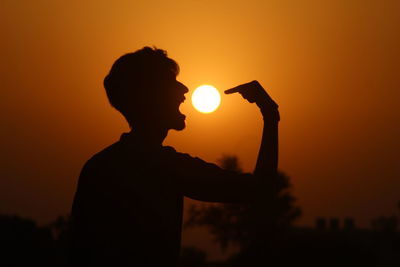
left=225, top=81, right=279, bottom=121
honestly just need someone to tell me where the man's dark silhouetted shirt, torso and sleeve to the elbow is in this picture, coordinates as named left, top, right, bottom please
left=70, top=133, right=256, bottom=267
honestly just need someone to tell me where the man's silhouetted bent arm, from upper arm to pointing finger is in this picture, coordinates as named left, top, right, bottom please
left=176, top=81, right=279, bottom=202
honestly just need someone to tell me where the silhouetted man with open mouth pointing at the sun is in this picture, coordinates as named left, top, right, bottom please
left=70, top=47, right=279, bottom=266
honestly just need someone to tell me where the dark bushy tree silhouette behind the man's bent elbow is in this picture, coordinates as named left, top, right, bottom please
left=185, top=156, right=301, bottom=256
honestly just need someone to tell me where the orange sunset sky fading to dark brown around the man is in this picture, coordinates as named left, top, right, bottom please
left=0, top=0, right=400, bottom=260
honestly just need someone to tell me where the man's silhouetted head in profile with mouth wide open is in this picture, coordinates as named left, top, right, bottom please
left=104, top=47, right=188, bottom=130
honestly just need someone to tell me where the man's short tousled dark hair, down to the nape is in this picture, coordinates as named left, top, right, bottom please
left=103, top=46, right=179, bottom=127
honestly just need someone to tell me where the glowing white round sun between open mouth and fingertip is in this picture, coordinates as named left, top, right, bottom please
left=192, top=85, right=221, bottom=113
